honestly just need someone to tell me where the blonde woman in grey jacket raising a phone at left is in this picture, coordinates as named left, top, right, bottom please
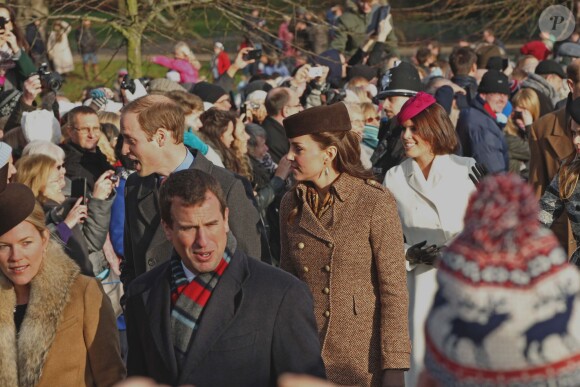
left=14, top=153, right=115, bottom=277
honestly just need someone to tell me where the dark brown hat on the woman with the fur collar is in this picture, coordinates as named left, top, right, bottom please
left=0, top=164, right=36, bottom=235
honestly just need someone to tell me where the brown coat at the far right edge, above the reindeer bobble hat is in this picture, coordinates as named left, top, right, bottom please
left=529, top=108, right=576, bottom=256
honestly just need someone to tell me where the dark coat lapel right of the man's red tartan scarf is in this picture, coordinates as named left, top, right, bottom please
left=179, top=252, right=249, bottom=384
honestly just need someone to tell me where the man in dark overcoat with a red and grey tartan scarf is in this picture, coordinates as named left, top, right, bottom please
left=125, top=169, right=325, bottom=387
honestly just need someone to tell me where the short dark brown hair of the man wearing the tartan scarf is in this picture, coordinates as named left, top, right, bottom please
left=159, top=169, right=227, bottom=227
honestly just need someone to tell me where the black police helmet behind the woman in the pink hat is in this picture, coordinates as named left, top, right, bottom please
left=377, top=62, right=423, bottom=99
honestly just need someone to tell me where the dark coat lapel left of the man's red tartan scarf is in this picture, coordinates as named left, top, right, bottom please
left=142, top=264, right=177, bottom=380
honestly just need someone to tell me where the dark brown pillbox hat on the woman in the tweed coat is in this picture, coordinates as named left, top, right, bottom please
left=283, top=102, right=352, bottom=138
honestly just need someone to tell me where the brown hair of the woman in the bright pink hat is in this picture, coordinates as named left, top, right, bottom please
left=411, top=103, right=458, bottom=155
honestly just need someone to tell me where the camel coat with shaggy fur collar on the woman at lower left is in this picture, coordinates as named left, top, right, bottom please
left=0, top=243, right=125, bottom=387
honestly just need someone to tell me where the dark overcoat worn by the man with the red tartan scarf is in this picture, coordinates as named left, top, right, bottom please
left=125, top=250, right=325, bottom=387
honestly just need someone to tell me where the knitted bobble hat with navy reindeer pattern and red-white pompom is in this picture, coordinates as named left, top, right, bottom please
left=425, top=175, right=580, bottom=386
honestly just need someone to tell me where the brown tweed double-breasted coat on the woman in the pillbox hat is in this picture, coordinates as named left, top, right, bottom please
left=280, top=173, right=410, bottom=386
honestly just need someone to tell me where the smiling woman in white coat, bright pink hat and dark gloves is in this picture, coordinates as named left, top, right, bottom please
left=383, top=92, right=475, bottom=387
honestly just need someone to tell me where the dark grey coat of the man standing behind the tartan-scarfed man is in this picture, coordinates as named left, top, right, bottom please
left=121, top=149, right=261, bottom=289
